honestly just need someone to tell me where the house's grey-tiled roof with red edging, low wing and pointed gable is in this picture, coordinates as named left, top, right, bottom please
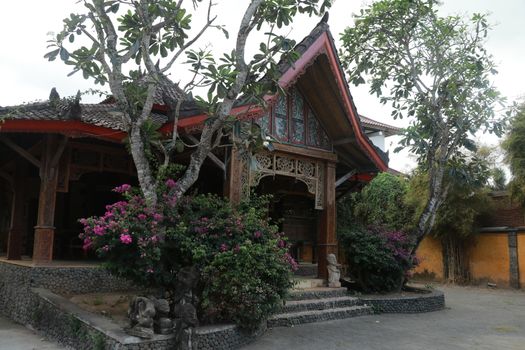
left=0, top=14, right=394, bottom=171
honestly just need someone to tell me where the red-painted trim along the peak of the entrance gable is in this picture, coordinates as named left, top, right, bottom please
left=279, top=32, right=388, bottom=171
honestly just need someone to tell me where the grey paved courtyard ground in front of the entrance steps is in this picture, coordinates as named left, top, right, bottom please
left=243, top=286, right=525, bottom=350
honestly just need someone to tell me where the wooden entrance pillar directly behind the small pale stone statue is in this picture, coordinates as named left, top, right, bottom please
left=317, top=162, right=337, bottom=279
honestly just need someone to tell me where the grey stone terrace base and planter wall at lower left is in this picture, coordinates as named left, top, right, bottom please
left=0, top=261, right=265, bottom=350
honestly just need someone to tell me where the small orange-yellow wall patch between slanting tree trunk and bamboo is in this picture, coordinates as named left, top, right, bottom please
left=413, top=236, right=443, bottom=280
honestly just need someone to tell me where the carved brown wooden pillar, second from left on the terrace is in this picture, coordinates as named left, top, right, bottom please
left=33, top=135, right=65, bottom=264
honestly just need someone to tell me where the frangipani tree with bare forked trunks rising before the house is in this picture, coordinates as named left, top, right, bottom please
left=45, top=0, right=333, bottom=205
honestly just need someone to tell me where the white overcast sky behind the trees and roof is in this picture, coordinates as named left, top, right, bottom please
left=0, top=0, right=525, bottom=171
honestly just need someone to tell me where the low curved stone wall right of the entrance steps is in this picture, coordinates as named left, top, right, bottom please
left=359, top=290, right=445, bottom=314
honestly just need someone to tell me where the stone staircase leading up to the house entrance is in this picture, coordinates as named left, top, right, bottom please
left=268, top=287, right=372, bottom=327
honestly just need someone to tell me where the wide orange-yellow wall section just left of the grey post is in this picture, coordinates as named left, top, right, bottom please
left=468, top=232, right=509, bottom=286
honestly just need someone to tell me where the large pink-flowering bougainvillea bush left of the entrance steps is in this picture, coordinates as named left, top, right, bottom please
left=80, top=179, right=296, bottom=328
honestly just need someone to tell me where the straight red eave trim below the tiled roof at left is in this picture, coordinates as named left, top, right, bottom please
left=0, top=119, right=127, bottom=142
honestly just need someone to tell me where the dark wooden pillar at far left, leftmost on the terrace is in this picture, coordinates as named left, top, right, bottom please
left=7, top=162, right=27, bottom=260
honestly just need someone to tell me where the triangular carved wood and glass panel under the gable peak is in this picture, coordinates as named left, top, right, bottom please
left=257, top=86, right=332, bottom=151
